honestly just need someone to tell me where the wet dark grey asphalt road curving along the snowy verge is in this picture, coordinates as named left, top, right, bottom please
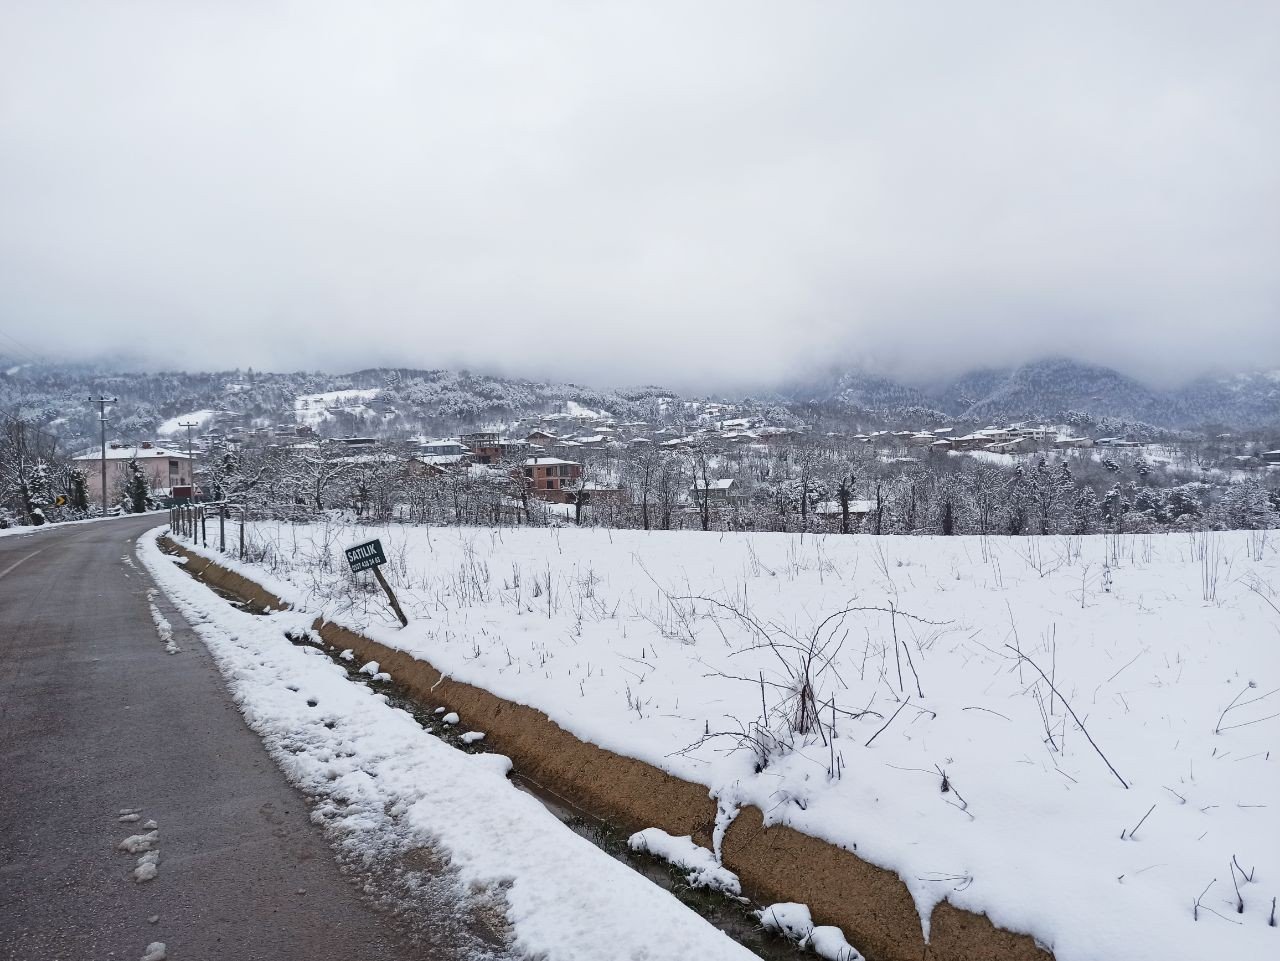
left=0, top=514, right=456, bottom=961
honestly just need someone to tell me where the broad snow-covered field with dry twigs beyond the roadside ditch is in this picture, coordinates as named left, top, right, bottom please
left=183, top=523, right=1280, bottom=961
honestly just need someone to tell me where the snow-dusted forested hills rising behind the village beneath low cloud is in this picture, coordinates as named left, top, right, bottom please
left=0, top=357, right=1280, bottom=447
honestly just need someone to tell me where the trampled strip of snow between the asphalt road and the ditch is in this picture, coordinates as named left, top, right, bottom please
left=131, top=535, right=755, bottom=961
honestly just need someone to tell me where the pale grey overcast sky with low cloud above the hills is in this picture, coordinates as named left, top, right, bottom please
left=0, top=0, right=1280, bottom=390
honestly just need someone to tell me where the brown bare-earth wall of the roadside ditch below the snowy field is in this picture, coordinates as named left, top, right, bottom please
left=161, top=537, right=1053, bottom=961
